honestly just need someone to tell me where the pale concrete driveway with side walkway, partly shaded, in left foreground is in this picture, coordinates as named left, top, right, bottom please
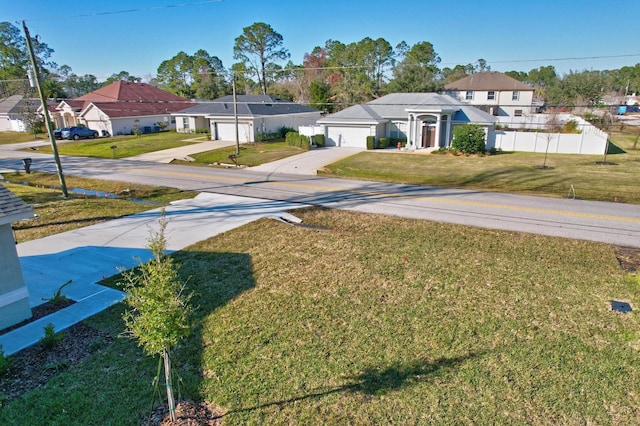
left=0, top=193, right=302, bottom=355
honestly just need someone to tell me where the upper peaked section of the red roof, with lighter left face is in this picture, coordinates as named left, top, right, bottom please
left=74, top=80, right=189, bottom=102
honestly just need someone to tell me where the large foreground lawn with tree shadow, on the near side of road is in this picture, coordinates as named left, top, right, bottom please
left=1, top=209, right=640, bottom=425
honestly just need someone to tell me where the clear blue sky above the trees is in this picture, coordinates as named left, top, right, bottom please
left=5, top=0, right=640, bottom=80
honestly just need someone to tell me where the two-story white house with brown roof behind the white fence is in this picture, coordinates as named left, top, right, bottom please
left=444, top=72, right=538, bottom=117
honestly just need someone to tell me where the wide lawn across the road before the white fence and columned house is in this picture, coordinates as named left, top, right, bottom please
left=320, top=128, right=640, bottom=204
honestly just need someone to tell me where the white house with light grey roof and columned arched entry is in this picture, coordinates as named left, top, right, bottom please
left=317, top=93, right=496, bottom=149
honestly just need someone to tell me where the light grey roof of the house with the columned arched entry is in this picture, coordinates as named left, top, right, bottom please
left=318, top=93, right=496, bottom=124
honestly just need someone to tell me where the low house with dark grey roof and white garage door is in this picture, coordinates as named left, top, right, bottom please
left=172, top=95, right=321, bottom=142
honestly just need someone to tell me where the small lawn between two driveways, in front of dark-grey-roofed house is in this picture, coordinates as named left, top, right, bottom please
left=173, top=140, right=306, bottom=167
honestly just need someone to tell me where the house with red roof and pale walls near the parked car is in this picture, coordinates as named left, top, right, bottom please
left=50, top=80, right=195, bottom=135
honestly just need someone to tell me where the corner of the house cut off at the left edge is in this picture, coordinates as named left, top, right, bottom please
left=0, top=185, right=33, bottom=329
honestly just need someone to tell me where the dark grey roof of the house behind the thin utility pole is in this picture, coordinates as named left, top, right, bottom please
left=176, top=95, right=320, bottom=117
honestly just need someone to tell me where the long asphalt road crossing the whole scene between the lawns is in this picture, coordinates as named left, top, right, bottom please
left=0, top=150, right=640, bottom=248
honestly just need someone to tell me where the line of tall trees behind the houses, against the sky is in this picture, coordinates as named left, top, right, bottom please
left=0, top=22, right=640, bottom=112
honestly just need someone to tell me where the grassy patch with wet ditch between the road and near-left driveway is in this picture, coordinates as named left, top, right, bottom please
left=3, top=173, right=195, bottom=242
